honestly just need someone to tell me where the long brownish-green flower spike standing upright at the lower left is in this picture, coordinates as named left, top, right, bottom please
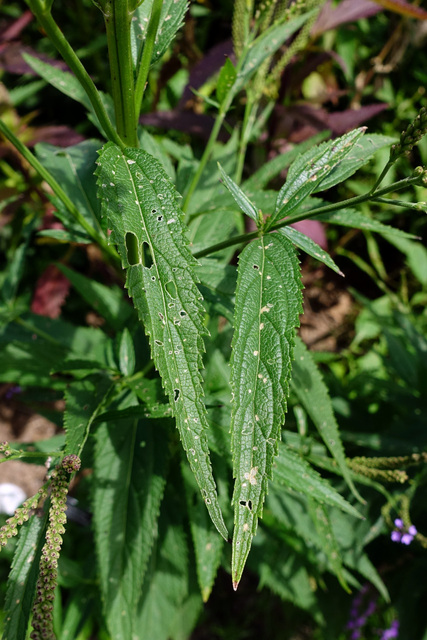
left=30, top=455, right=80, bottom=640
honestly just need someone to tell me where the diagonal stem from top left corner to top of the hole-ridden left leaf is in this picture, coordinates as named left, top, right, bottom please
left=25, top=0, right=123, bottom=147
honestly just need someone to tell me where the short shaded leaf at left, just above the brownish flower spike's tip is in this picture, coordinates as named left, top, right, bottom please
left=64, top=374, right=113, bottom=457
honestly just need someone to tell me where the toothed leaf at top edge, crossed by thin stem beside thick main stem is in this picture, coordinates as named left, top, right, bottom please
left=131, top=0, right=189, bottom=67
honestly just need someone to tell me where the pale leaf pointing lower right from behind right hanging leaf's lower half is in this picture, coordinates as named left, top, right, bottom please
left=274, top=443, right=362, bottom=518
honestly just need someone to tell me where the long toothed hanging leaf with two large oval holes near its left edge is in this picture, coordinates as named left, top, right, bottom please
left=97, top=143, right=228, bottom=538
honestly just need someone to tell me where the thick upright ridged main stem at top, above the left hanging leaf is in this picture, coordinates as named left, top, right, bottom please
left=104, top=0, right=138, bottom=147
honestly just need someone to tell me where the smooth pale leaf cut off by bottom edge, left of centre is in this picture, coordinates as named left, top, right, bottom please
left=136, top=492, right=188, bottom=640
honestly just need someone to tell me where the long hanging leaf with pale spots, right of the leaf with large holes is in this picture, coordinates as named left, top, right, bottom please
left=231, top=234, right=302, bottom=589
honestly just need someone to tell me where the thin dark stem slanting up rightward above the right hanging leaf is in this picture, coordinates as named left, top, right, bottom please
left=193, top=176, right=419, bottom=258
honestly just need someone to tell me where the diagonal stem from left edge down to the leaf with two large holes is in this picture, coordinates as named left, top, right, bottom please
left=0, top=120, right=117, bottom=261
